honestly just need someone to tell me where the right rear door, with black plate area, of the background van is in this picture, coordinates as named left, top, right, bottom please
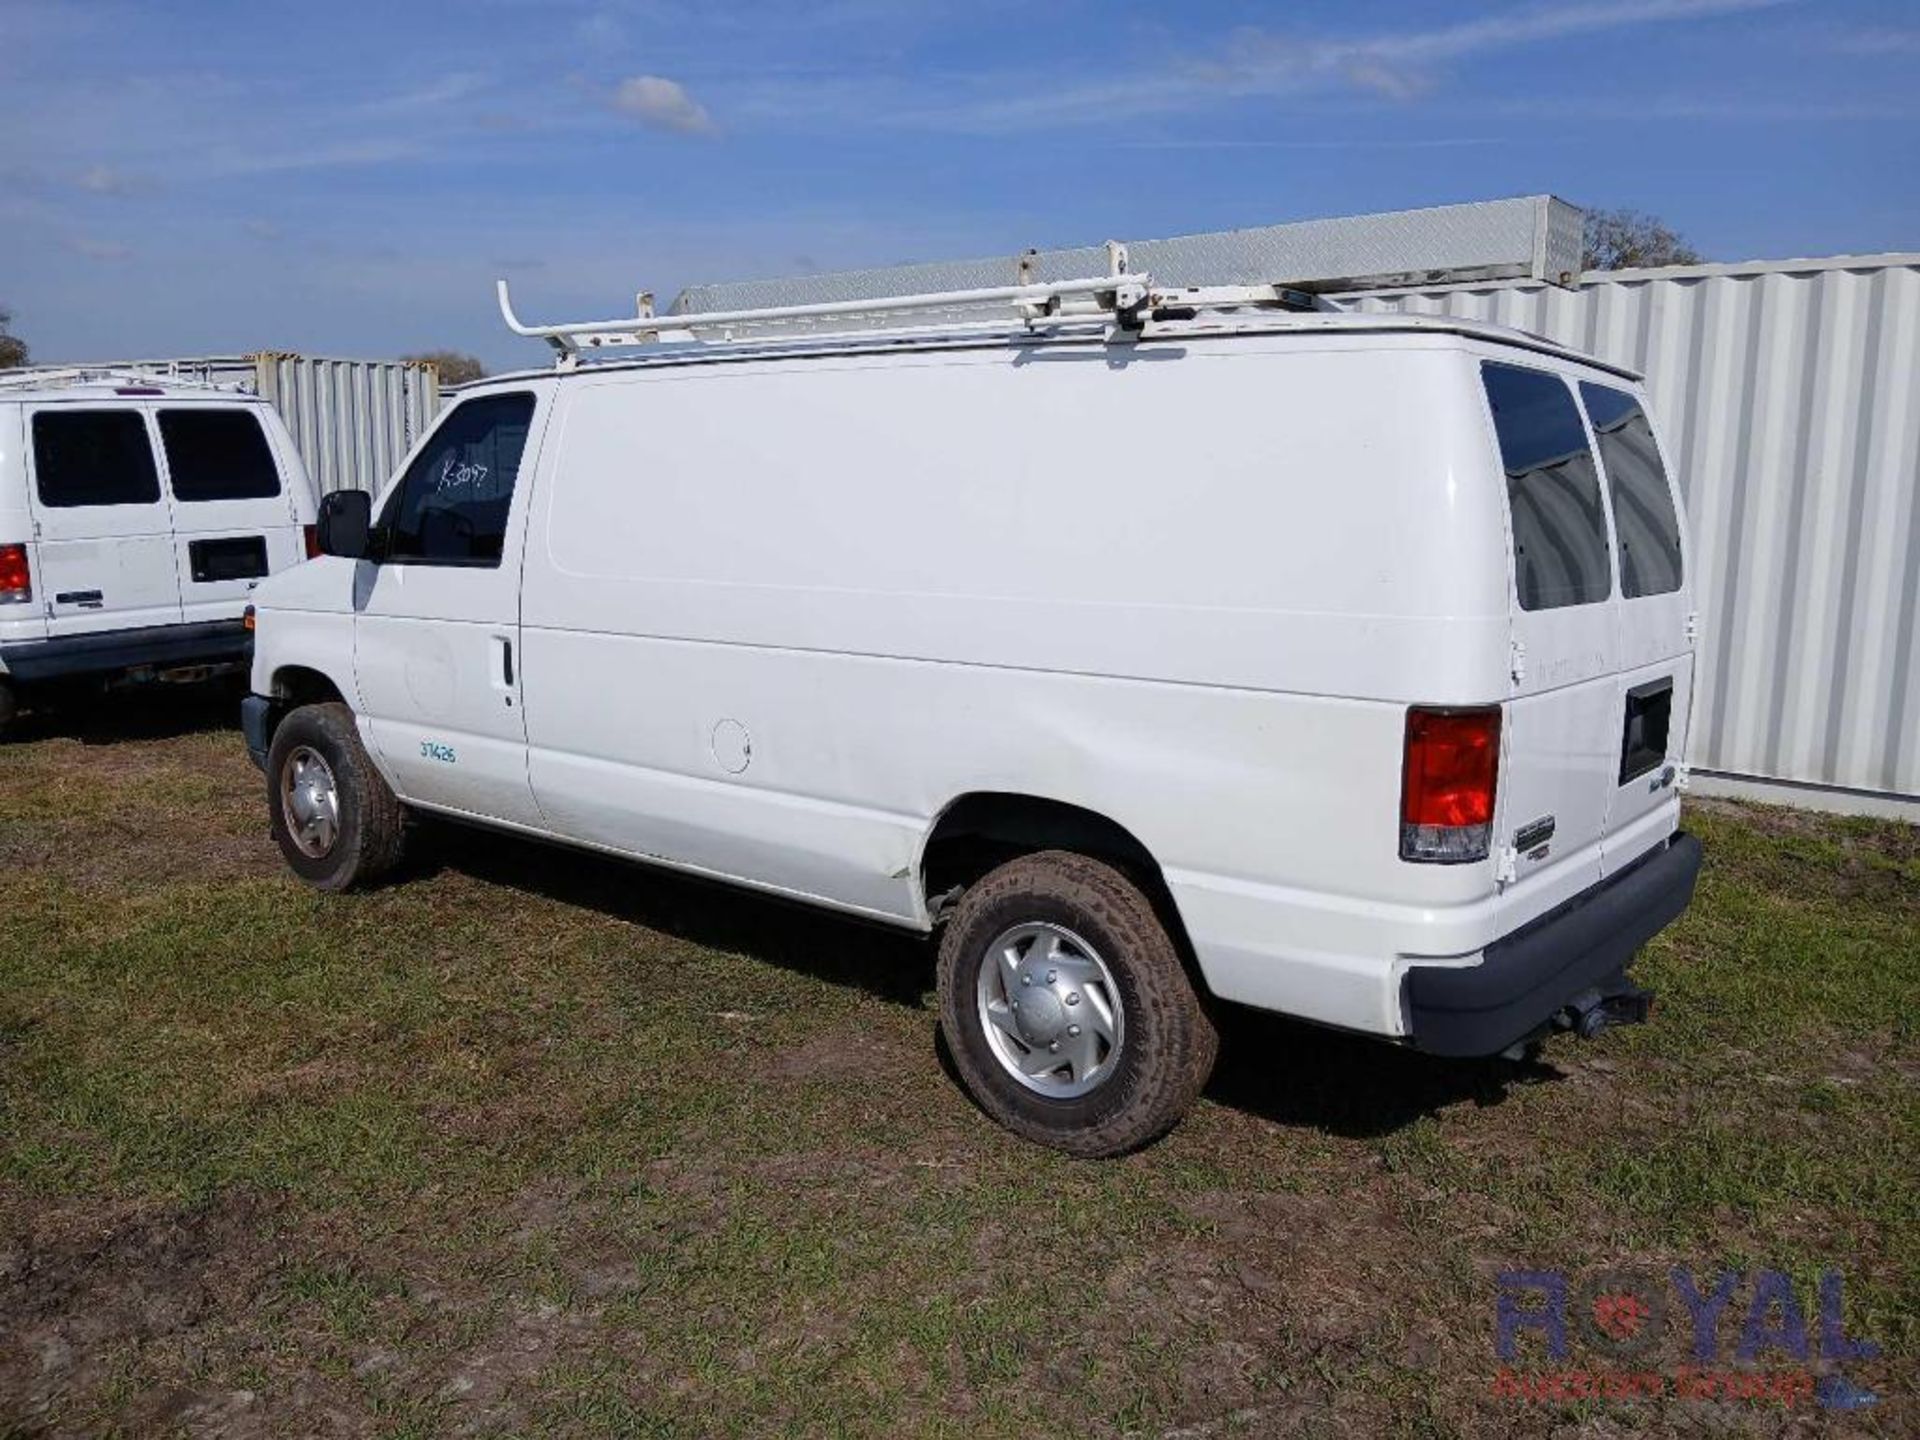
left=156, top=403, right=305, bottom=622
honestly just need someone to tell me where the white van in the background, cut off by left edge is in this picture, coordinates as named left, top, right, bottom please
left=0, top=371, right=315, bottom=728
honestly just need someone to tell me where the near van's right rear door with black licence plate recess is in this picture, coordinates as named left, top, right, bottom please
left=1580, top=380, right=1695, bottom=874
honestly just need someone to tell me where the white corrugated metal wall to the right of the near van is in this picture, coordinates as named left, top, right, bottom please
left=1334, top=255, right=1920, bottom=801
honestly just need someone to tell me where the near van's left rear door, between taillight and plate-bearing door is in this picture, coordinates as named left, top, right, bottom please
left=1480, top=361, right=1620, bottom=924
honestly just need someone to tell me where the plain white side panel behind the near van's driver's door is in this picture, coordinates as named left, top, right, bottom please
left=522, top=338, right=1509, bottom=1033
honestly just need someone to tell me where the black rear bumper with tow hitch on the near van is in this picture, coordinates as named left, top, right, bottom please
left=1404, top=833, right=1701, bottom=1056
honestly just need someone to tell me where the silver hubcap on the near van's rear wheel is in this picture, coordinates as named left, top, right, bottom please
left=975, top=922, right=1127, bottom=1100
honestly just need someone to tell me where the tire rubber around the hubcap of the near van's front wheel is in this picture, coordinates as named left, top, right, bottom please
left=267, top=701, right=407, bottom=891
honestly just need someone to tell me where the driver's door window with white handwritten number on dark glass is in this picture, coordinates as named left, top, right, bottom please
left=380, top=396, right=534, bottom=564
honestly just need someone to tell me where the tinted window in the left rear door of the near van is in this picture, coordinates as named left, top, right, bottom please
left=1480, top=365, right=1613, bottom=611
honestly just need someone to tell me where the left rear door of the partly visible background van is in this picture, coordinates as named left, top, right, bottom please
left=27, top=401, right=180, bottom=639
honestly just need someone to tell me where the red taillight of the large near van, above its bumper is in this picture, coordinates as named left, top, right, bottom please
left=1400, top=705, right=1500, bottom=864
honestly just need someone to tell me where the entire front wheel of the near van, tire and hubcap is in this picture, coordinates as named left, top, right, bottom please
left=267, top=703, right=407, bottom=891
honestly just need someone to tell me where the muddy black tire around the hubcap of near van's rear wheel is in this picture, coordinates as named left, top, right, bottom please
left=939, top=851, right=1219, bottom=1158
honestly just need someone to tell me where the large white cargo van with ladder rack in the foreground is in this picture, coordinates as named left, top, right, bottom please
left=246, top=276, right=1699, bottom=1154
